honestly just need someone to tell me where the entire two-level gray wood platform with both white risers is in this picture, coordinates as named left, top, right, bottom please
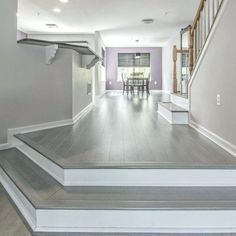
left=0, top=91, right=236, bottom=232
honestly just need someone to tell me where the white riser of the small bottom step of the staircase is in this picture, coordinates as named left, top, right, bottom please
left=158, top=104, right=189, bottom=125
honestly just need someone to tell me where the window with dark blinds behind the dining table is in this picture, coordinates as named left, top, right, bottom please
left=117, top=53, right=151, bottom=81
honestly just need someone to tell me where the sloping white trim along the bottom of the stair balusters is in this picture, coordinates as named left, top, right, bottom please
left=189, top=0, right=229, bottom=89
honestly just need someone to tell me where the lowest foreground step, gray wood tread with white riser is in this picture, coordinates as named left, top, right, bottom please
left=0, top=149, right=236, bottom=233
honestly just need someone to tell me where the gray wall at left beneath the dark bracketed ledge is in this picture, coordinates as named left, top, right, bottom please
left=0, top=0, right=77, bottom=143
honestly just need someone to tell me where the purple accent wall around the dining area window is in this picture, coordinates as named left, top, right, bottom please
left=106, top=47, right=162, bottom=90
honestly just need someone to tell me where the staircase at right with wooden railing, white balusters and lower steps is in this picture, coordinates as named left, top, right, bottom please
left=158, top=0, right=227, bottom=124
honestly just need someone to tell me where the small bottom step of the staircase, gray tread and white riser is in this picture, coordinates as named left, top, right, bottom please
left=158, top=102, right=189, bottom=125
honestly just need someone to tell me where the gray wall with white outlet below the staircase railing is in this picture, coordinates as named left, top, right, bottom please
left=191, top=0, right=236, bottom=145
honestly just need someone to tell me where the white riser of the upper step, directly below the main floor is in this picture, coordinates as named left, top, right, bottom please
left=14, top=138, right=236, bottom=187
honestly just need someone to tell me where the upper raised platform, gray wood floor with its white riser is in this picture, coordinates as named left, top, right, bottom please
left=8, top=94, right=236, bottom=186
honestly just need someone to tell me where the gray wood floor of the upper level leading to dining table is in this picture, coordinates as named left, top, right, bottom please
left=18, top=93, right=236, bottom=168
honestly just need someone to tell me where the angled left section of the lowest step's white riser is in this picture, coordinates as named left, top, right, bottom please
left=0, top=168, right=36, bottom=230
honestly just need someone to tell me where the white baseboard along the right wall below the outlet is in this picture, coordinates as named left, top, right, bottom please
left=189, top=120, right=236, bottom=157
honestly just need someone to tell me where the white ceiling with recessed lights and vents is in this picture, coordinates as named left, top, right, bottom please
left=18, top=0, right=199, bottom=47
